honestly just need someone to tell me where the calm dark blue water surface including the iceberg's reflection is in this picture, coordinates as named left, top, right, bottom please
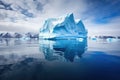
left=0, top=39, right=120, bottom=80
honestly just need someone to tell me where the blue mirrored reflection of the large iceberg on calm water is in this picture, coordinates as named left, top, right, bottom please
left=39, top=39, right=87, bottom=62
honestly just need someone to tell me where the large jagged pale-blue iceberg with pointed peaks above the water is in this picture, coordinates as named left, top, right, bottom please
left=39, top=13, right=87, bottom=39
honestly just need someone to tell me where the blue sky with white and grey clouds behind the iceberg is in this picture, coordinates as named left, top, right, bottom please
left=0, top=0, right=120, bottom=35
